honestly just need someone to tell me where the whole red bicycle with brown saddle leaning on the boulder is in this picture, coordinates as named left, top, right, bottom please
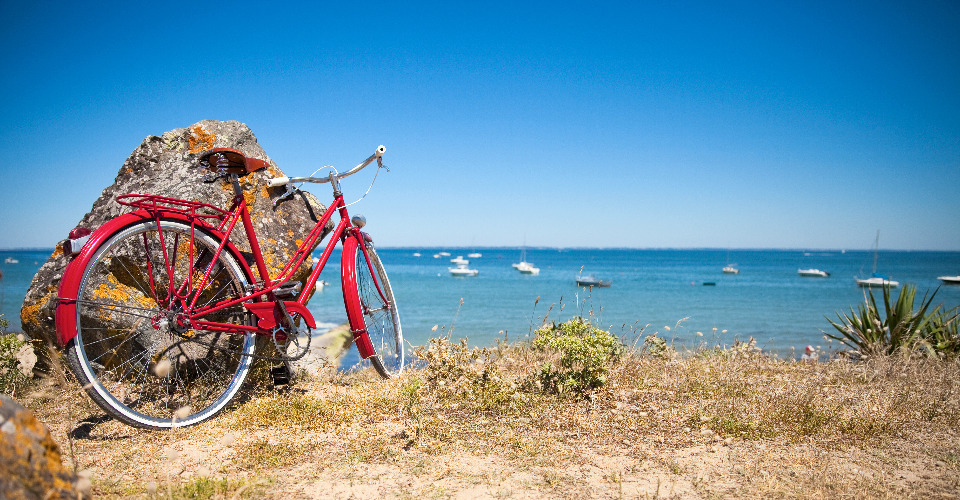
left=56, top=146, right=404, bottom=429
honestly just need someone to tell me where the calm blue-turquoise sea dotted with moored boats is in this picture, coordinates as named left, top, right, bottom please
left=0, top=248, right=960, bottom=357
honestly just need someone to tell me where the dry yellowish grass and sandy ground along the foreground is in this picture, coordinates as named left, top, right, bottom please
left=15, top=343, right=960, bottom=498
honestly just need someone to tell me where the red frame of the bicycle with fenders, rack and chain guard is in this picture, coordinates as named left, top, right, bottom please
left=57, top=169, right=386, bottom=359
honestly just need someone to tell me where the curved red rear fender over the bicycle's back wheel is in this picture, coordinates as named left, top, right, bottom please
left=55, top=210, right=256, bottom=345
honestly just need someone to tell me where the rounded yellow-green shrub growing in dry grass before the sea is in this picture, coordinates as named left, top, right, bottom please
left=533, top=317, right=624, bottom=396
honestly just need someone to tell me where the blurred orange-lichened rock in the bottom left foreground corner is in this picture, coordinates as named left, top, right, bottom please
left=0, top=394, right=89, bottom=499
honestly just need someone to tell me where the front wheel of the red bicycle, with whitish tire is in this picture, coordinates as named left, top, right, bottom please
left=344, top=243, right=405, bottom=378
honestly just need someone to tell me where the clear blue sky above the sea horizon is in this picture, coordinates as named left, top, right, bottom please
left=0, top=0, right=960, bottom=250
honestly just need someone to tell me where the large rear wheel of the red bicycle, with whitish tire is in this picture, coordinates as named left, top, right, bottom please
left=66, top=218, right=256, bottom=429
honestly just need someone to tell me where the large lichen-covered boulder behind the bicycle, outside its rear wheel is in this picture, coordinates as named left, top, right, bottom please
left=20, top=120, right=333, bottom=345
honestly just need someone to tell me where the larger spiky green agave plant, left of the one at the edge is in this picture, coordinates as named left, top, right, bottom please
left=827, top=285, right=940, bottom=354
